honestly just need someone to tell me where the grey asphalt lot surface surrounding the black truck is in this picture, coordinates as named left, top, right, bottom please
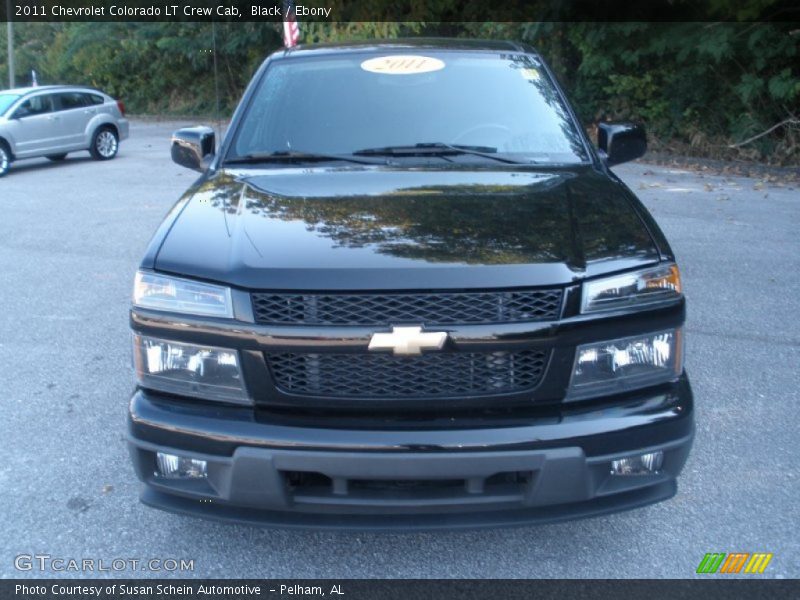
left=0, top=122, right=800, bottom=578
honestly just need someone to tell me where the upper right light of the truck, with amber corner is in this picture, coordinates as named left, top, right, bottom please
left=581, top=264, right=681, bottom=313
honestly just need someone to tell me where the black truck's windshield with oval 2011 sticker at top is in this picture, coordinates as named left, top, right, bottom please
left=227, top=51, right=587, bottom=164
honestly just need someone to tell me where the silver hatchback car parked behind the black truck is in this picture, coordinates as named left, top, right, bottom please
left=0, top=86, right=128, bottom=177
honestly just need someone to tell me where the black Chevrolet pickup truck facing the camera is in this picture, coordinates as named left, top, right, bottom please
left=128, top=40, right=694, bottom=529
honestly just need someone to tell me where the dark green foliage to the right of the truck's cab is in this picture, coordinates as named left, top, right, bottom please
left=512, top=20, right=800, bottom=164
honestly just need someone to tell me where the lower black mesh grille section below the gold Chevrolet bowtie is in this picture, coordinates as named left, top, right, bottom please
left=266, top=350, right=550, bottom=400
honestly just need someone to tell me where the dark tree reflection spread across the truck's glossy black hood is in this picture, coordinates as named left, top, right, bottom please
left=196, top=164, right=653, bottom=264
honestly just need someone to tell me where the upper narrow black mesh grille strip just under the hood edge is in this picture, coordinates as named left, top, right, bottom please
left=252, top=289, right=562, bottom=326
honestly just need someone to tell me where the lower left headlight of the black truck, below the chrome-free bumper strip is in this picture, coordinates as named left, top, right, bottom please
left=133, top=335, right=250, bottom=404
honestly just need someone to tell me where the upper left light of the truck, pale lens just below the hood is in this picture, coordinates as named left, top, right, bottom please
left=133, top=271, right=233, bottom=318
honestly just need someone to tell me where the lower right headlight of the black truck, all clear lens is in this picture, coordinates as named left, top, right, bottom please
left=567, top=329, right=683, bottom=400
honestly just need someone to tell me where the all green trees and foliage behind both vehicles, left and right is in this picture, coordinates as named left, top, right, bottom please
left=0, top=19, right=800, bottom=163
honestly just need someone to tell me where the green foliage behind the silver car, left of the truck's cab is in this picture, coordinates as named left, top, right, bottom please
left=0, top=23, right=281, bottom=115
